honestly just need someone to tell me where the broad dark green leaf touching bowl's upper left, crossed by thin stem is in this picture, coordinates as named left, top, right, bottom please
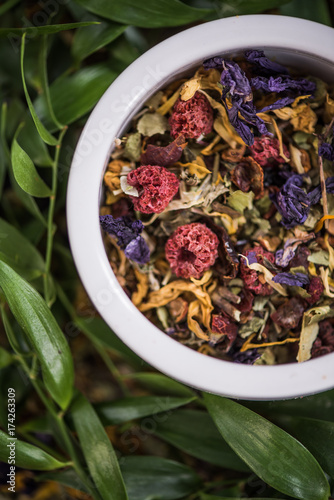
left=34, top=64, right=118, bottom=131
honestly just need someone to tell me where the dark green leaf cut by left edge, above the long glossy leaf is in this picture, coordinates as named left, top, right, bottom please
left=0, top=218, right=45, bottom=279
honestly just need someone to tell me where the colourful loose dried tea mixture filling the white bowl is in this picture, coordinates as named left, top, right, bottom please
left=100, top=50, right=334, bottom=364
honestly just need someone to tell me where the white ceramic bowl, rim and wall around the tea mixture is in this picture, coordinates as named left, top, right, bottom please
left=67, top=15, right=334, bottom=400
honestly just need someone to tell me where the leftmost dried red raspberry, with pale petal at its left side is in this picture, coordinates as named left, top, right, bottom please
left=127, top=165, right=179, bottom=214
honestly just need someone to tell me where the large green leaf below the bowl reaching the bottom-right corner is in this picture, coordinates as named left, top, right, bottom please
left=204, top=394, right=330, bottom=500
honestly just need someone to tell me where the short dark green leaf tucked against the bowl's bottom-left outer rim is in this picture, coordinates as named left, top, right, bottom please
left=124, top=372, right=194, bottom=397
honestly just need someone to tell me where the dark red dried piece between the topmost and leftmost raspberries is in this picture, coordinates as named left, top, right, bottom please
left=140, top=135, right=187, bottom=167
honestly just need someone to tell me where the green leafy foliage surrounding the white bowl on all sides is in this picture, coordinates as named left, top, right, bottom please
left=0, top=0, right=334, bottom=500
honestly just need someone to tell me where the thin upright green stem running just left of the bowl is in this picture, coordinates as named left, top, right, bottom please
left=43, top=126, right=67, bottom=307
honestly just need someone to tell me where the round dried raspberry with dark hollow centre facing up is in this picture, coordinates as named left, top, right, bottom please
left=165, top=222, right=219, bottom=279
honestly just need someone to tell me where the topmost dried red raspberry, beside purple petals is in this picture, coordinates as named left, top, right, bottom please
left=168, top=92, right=213, bottom=139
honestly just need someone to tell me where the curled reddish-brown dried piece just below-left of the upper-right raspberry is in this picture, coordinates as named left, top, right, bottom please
left=231, top=156, right=264, bottom=200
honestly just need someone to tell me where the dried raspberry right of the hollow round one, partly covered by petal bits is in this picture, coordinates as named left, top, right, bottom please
left=240, top=246, right=275, bottom=295
